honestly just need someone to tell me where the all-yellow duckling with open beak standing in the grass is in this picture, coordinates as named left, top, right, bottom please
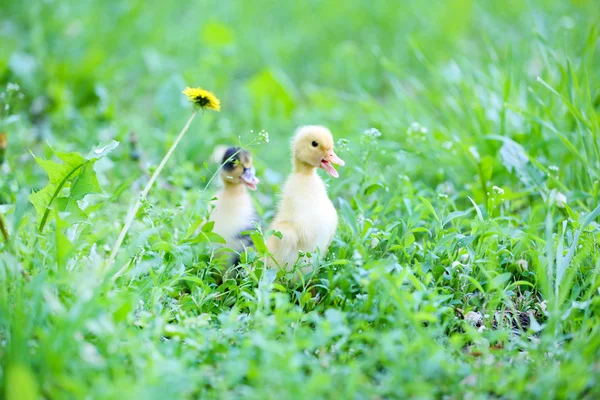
left=267, top=125, right=345, bottom=273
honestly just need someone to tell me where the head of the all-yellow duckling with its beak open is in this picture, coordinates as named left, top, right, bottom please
left=292, top=125, right=345, bottom=178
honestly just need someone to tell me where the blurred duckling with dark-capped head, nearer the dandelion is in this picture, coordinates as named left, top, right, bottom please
left=209, top=147, right=259, bottom=265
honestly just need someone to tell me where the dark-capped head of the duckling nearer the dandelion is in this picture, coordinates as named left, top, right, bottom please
left=213, top=147, right=259, bottom=190
